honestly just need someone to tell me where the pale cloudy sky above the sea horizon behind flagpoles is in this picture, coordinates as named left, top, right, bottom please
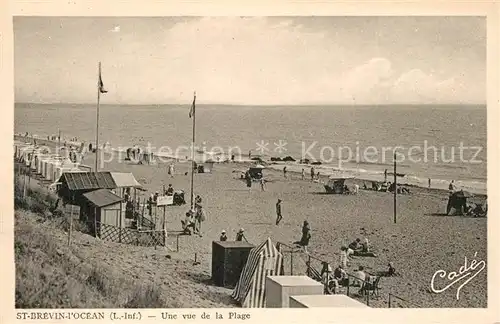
left=14, top=16, right=486, bottom=105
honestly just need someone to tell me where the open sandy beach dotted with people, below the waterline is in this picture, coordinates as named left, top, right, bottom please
left=13, top=137, right=487, bottom=307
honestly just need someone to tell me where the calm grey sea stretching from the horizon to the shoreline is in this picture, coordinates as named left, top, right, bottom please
left=14, top=103, right=487, bottom=193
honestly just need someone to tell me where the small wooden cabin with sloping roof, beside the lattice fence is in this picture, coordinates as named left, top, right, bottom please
left=80, top=189, right=125, bottom=237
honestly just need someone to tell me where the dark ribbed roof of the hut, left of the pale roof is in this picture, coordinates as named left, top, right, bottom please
left=61, top=172, right=116, bottom=190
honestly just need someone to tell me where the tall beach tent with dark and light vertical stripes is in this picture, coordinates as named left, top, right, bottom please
left=231, top=238, right=283, bottom=308
